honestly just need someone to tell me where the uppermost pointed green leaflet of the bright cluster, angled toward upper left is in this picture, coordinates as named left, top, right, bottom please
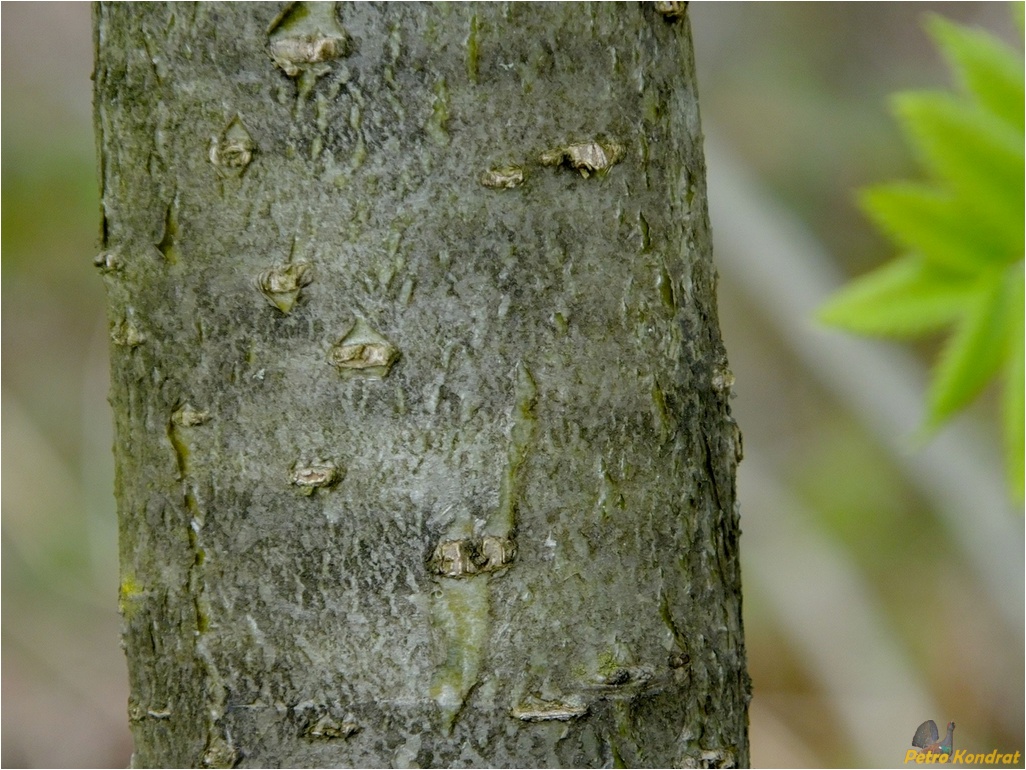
left=926, top=13, right=1026, bottom=131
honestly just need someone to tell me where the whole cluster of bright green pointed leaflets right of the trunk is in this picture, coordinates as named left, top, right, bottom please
left=819, top=12, right=1026, bottom=497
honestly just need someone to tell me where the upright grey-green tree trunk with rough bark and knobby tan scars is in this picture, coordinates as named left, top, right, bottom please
left=95, top=3, right=749, bottom=767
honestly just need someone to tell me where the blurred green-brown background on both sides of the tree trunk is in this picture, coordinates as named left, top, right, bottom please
left=0, top=2, right=1026, bottom=767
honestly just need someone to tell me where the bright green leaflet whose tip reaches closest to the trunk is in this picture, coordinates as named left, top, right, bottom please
left=819, top=255, right=972, bottom=337
